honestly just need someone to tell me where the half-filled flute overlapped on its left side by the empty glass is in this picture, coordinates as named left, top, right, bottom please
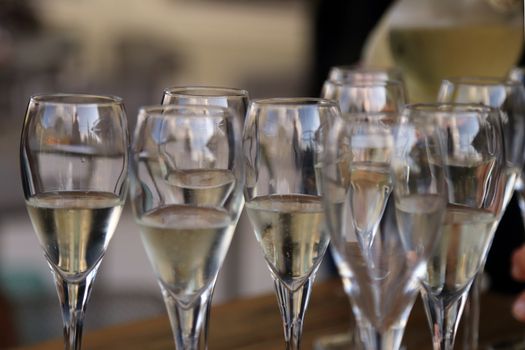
left=417, top=104, right=508, bottom=350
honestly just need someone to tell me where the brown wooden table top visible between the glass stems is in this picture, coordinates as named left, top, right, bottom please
left=15, top=279, right=525, bottom=350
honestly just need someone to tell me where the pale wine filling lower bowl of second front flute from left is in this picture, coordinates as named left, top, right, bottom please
left=138, top=205, right=235, bottom=303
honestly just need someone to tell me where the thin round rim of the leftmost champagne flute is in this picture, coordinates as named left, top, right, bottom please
left=30, top=93, right=123, bottom=107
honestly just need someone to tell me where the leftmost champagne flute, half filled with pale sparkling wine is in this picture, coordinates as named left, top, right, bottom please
left=20, top=94, right=128, bottom=349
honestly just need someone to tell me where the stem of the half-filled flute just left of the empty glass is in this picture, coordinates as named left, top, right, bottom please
left=274, top=272, right=315, bottom=350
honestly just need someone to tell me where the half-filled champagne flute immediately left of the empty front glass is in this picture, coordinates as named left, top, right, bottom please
left=243, top=98, right=340, bottom=350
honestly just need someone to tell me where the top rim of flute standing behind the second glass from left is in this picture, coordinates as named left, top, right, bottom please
left=162, top=86, right=249, bottom=123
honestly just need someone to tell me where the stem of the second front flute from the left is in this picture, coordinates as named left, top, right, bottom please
left=161, top=285, right=213, bottom=350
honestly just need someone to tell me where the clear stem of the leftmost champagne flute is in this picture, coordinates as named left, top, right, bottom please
left=52, top=262, right=100, bottom=350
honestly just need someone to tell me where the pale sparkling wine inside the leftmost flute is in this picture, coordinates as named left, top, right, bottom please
left=27, top=192, right=123, bottom=278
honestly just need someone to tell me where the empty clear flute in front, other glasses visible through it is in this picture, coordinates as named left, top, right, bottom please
left=321, top=102, right=446, bottom=350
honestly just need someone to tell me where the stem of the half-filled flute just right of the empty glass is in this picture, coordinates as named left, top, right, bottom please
left=421, top=286, right=470, bottom=350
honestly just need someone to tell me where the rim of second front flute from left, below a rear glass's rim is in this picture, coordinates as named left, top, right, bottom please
left=139, top=104, right=235, bottom=119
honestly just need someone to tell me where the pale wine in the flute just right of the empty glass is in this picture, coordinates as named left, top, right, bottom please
left=423, top=204, right=497, bottom=295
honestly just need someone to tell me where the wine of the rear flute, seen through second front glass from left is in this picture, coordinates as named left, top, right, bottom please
left=167, top=169, right=235, bottom=207
